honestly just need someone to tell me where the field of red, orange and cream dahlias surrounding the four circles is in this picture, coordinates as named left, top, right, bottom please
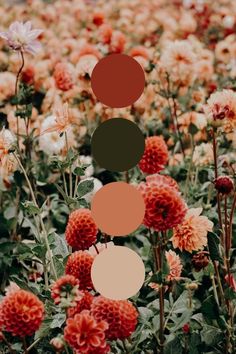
left=0, top=0, right=236, bottom=354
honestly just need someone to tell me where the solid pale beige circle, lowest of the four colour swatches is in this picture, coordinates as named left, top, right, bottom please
left=91, top=246, right=145, bottom=300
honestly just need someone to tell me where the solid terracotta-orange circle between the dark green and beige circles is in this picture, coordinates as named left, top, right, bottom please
left=91, top=182, right=145, bottom=236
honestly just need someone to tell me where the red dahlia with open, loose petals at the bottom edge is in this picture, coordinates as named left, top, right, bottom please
left=64, top=310, right=109, bottom=354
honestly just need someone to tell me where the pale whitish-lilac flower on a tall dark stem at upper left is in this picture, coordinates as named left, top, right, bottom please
left=0, top=21, right=43, bottom=54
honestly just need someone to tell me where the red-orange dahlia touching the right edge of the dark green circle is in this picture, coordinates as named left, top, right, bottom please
left=139, top=136, right=168, bottom=174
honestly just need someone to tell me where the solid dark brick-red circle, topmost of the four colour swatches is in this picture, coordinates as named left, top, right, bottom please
left=91, top=54, right=145, bottom=108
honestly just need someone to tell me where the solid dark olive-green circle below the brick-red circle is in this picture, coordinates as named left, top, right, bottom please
left=91, top=118, right=145, bottom=172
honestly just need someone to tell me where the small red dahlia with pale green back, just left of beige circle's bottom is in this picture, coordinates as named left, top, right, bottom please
left=51, top=275, right=82, bottom=307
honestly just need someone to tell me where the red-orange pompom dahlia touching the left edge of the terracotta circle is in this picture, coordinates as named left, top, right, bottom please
left=66, top=209, right=98, bottom=250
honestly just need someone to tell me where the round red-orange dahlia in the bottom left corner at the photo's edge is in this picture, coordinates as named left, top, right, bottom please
left=1, top=289, right=44, bottom=337
